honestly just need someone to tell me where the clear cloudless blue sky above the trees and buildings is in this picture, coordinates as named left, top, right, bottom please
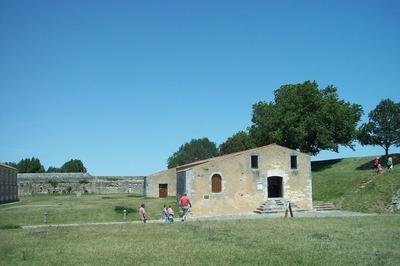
left=0, top=0, right=400, bottom=175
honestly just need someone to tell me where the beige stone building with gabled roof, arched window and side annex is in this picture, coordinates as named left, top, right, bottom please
left=146, top=144, right=312, bottom=216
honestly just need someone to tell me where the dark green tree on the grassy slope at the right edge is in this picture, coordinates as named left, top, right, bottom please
left=358, top=99, right=400, bottom=157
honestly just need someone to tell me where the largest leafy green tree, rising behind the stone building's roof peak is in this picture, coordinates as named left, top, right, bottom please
left=250, top=81, right=362, bottom=155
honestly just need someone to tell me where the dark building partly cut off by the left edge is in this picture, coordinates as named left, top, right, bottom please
left=0, top=164, right=18, bottom=204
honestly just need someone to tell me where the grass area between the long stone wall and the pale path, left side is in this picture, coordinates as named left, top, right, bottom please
left=0, top=194, right=178, bottom=228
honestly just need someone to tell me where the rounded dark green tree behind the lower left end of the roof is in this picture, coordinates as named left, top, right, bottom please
left=167, top=138, right=218, bottom=168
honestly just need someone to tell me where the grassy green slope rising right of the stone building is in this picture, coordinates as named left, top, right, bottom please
left=312, top=154, right=400, bottom=213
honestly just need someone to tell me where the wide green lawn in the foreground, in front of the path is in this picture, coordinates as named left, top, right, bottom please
left=0, top=215, right=400, bottom=265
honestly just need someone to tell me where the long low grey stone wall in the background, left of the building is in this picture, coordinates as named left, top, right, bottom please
left=18, top=173, right=145, bottom=196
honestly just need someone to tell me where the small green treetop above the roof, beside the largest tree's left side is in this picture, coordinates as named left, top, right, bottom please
left=219, top=131, right=256, bottom=155
